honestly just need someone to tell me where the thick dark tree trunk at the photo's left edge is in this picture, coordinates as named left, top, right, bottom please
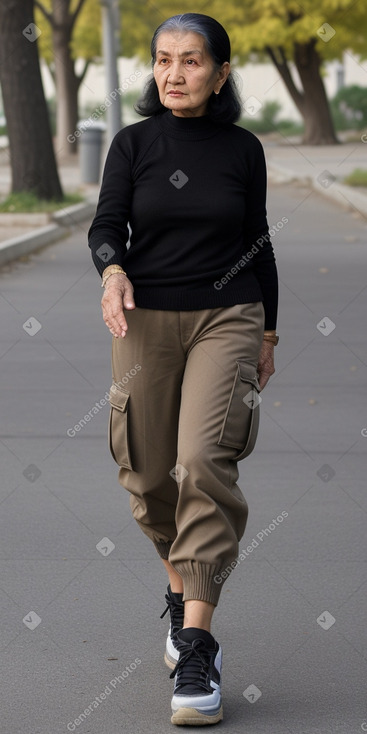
left=0, top=0, right=63, bottom=200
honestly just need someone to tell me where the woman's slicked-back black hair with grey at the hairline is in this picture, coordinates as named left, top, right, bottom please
left=134, top=13, right=242, bottom=124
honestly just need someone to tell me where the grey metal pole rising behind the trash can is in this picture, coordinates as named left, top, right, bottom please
left=101, top=0, right=122, bottom=144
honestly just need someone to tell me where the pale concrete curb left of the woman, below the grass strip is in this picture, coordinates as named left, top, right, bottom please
left=0, top=201, right=96, bottom=266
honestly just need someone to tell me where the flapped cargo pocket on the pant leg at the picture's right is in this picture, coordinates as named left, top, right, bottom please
left=218, top=360, right=261, bottom=461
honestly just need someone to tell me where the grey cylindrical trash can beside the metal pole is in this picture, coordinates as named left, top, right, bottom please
left=78, top=120, right=106, bottom=184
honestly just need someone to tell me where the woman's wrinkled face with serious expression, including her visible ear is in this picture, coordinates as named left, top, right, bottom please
left=153, top=31, right=230, bottom=117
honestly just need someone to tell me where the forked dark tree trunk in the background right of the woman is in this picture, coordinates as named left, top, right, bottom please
left=266, top=40, right=339, bottom=145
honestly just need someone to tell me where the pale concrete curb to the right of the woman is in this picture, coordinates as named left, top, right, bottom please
left=267, top=167, right=367, bottom=221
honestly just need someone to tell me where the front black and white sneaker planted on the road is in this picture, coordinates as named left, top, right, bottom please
left=170, top=627, right=223, bottom=726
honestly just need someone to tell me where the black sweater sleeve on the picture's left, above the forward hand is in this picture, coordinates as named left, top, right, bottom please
left=88, top=131, right=132, bottom=275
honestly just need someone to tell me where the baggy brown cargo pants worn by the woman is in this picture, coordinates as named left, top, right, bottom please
left=109, top=302, right=264, bottom=604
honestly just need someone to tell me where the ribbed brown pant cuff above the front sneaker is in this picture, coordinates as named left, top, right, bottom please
left=172, top=561, right=223, bottom=606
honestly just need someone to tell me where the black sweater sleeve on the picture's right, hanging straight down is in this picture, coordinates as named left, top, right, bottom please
left=244, top=138, right=278, bottom=329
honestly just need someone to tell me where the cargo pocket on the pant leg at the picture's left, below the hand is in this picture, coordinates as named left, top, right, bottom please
left=108, top=383, right=132, bottom=469
